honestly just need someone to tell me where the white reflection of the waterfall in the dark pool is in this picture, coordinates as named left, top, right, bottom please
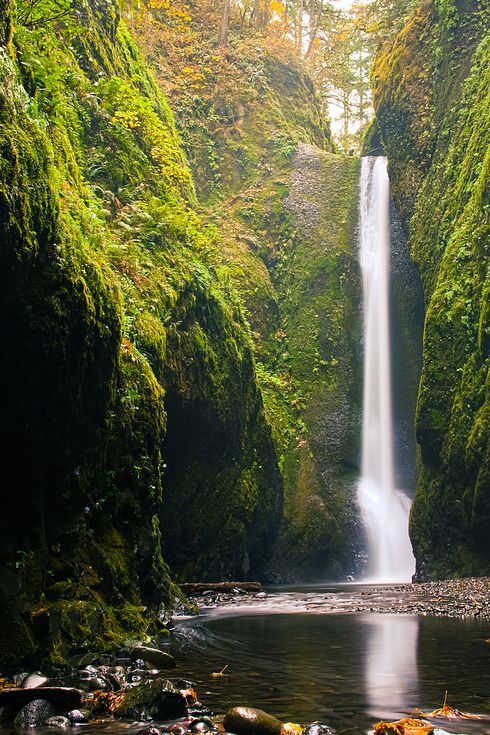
left=363, top=615, right=419, bottom=719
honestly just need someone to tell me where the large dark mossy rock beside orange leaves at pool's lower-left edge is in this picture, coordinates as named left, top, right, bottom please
left=114, top=678, right=187, bottom=721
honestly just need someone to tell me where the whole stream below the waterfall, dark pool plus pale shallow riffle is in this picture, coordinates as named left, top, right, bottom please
left=0, top=580, right=490, bottom=735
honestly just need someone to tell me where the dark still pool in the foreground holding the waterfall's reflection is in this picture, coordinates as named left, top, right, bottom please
left=173, top=604, right=490, bottom=733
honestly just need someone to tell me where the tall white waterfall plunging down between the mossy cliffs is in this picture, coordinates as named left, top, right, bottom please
left=357, top=156, right=415, bottom=582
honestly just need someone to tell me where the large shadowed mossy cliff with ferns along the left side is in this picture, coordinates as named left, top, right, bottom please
left=0, top=0, right=282, bottom=670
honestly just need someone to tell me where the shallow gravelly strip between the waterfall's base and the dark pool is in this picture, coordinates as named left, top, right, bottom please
left=186, top=577, right=490, bottom=620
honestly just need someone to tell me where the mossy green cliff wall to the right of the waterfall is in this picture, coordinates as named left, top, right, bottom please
left=373, top=0, right=490, bottom=577
